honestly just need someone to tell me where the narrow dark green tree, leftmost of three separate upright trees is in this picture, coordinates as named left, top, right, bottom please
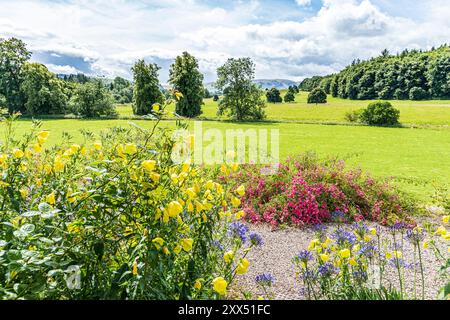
left=131, top=59, right=164, bottom=115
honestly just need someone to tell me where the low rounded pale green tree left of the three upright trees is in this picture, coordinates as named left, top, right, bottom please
left=70, top=81, right=117, bottom=118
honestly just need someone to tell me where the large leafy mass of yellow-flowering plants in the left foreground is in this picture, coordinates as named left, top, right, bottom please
left=0, top=105, right=261, bottom=299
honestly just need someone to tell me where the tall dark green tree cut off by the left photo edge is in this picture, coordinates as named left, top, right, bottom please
left=0, top=38, right=31, bottom=113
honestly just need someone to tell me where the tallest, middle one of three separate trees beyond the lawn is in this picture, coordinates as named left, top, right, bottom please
left=169, top=52, right=205, bottom=118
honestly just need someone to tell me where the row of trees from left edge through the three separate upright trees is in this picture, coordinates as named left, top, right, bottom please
left=0, top=38, right=266, bottom=120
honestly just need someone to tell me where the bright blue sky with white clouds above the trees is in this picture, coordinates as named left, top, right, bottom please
left=0, top=0, right=450, bottom=83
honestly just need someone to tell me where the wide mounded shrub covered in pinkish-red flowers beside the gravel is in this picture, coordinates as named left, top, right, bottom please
left=223, top=154, right=416, bottom=226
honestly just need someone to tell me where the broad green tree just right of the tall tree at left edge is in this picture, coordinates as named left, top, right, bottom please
left=20, top=63, right=67, bottom=115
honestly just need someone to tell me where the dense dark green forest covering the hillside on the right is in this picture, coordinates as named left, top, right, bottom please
left=299, top=45, right=450, bottom=100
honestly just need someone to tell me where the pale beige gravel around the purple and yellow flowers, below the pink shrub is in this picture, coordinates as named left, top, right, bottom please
left=233, top=220, right=447, bottom=300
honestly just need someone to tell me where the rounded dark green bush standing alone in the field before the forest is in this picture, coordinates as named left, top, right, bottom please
left=361, top=101, right=400, bottom=126
